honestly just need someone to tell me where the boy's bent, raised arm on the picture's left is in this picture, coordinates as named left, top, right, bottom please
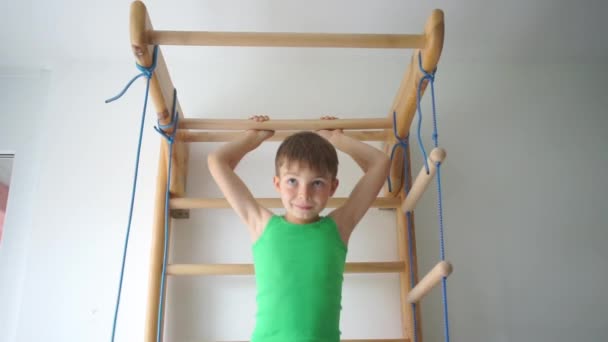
left=207, top=119, right=274, bottom=240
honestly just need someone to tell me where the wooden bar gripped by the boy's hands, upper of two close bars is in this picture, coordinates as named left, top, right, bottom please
left=179, top=118, right=393, bottom=131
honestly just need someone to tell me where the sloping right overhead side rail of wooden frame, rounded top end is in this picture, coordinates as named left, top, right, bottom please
left=385, top=9, right=445, bottom=196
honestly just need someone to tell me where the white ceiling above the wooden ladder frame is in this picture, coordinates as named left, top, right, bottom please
left=0, top=0, right=608, bottom=67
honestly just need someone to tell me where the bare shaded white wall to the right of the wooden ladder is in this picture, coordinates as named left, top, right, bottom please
left=417, top=64, right=608, bottom=341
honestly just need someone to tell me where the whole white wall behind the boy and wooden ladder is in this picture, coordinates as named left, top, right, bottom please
left=0, top=55, right=608, bottom=342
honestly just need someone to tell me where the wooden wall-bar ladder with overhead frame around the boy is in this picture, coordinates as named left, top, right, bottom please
left=130, top=1, right=444, bottom=342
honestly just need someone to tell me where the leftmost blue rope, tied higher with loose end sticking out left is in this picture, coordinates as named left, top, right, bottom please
left=106, top=46, right=158, bottom=342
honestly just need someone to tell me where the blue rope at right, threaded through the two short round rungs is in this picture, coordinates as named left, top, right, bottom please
left=417, top=52, right=450, bottom=342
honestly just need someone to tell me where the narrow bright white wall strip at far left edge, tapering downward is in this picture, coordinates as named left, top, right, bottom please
left=0, top=68, right=49, bottom=341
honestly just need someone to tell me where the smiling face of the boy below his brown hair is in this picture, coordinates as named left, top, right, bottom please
left=274, top=162, right=338, bottom=224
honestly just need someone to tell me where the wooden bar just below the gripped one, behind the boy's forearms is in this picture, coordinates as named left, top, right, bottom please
left=177, top=129, right=392, bottom=142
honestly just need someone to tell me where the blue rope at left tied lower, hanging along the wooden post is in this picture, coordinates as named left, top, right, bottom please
left=154, top=89, right=179, bottom=342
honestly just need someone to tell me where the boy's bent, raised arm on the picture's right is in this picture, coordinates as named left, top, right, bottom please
left=319, top=120, right=390, bottom=240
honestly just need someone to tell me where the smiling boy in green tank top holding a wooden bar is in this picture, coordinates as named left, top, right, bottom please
left=208, top=116, right=390, bottom=342
